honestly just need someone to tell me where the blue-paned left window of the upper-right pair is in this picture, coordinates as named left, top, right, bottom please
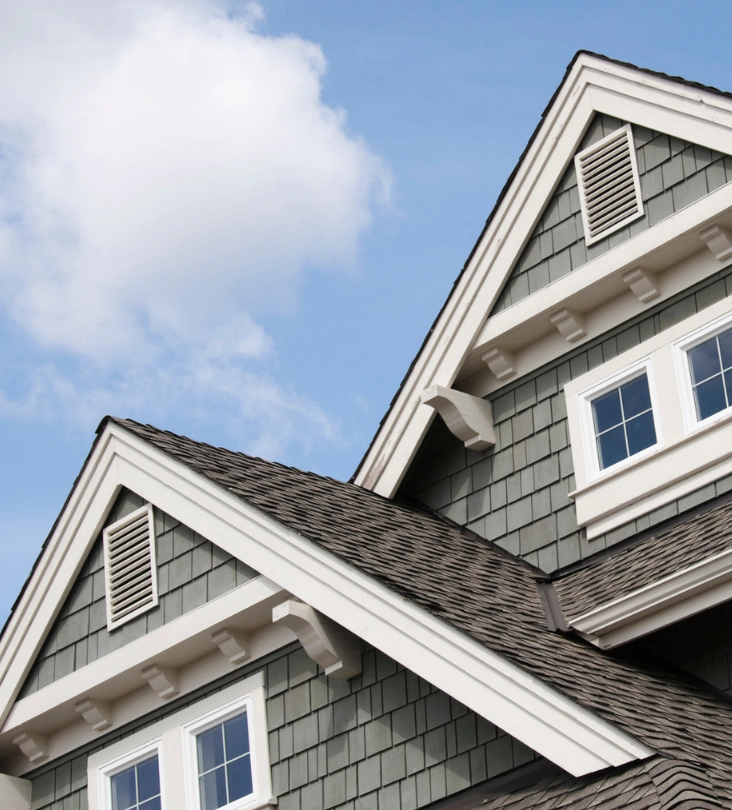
left=592, top=373, right=656, bottom=470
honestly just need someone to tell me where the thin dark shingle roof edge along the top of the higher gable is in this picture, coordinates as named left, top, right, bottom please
left=350, top=49, right=732, bottom=481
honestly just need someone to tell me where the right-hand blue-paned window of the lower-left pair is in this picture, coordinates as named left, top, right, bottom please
left=184, top=699, right=254, bottom=810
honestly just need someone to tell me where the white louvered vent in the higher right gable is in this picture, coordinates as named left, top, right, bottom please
left=574, top=124, right=643, bottom=245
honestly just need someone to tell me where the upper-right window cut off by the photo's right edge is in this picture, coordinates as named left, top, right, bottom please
left=686, top=329, right=732, bottom=422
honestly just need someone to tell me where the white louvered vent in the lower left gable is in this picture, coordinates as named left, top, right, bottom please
left=103, top=504, right=158, bottom=630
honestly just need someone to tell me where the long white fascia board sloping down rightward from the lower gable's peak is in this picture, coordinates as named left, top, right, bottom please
left=60, top=424, right=651, bottom=775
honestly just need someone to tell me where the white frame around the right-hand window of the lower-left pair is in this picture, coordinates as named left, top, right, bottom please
left=183, top=695, right=261, bottom=810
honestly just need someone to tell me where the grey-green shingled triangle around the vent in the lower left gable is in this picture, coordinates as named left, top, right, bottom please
left=19, top=489, right=258, bottom=699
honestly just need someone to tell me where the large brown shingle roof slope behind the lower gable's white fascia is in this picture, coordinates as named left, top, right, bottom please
left=112, top=419, right=732, bottom=807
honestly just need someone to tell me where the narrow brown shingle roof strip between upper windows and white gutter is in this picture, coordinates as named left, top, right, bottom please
left=552, top=497, right=732, bottom=620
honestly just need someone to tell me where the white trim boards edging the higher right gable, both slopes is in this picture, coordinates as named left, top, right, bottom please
left=354, top=53, right=732, bottom=497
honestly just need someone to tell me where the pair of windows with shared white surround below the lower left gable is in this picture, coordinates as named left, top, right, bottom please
left=88, top=672, right=274, bottom=810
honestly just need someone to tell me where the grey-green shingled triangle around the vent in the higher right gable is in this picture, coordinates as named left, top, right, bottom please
left=491, top=113, right=732, bottom=315
